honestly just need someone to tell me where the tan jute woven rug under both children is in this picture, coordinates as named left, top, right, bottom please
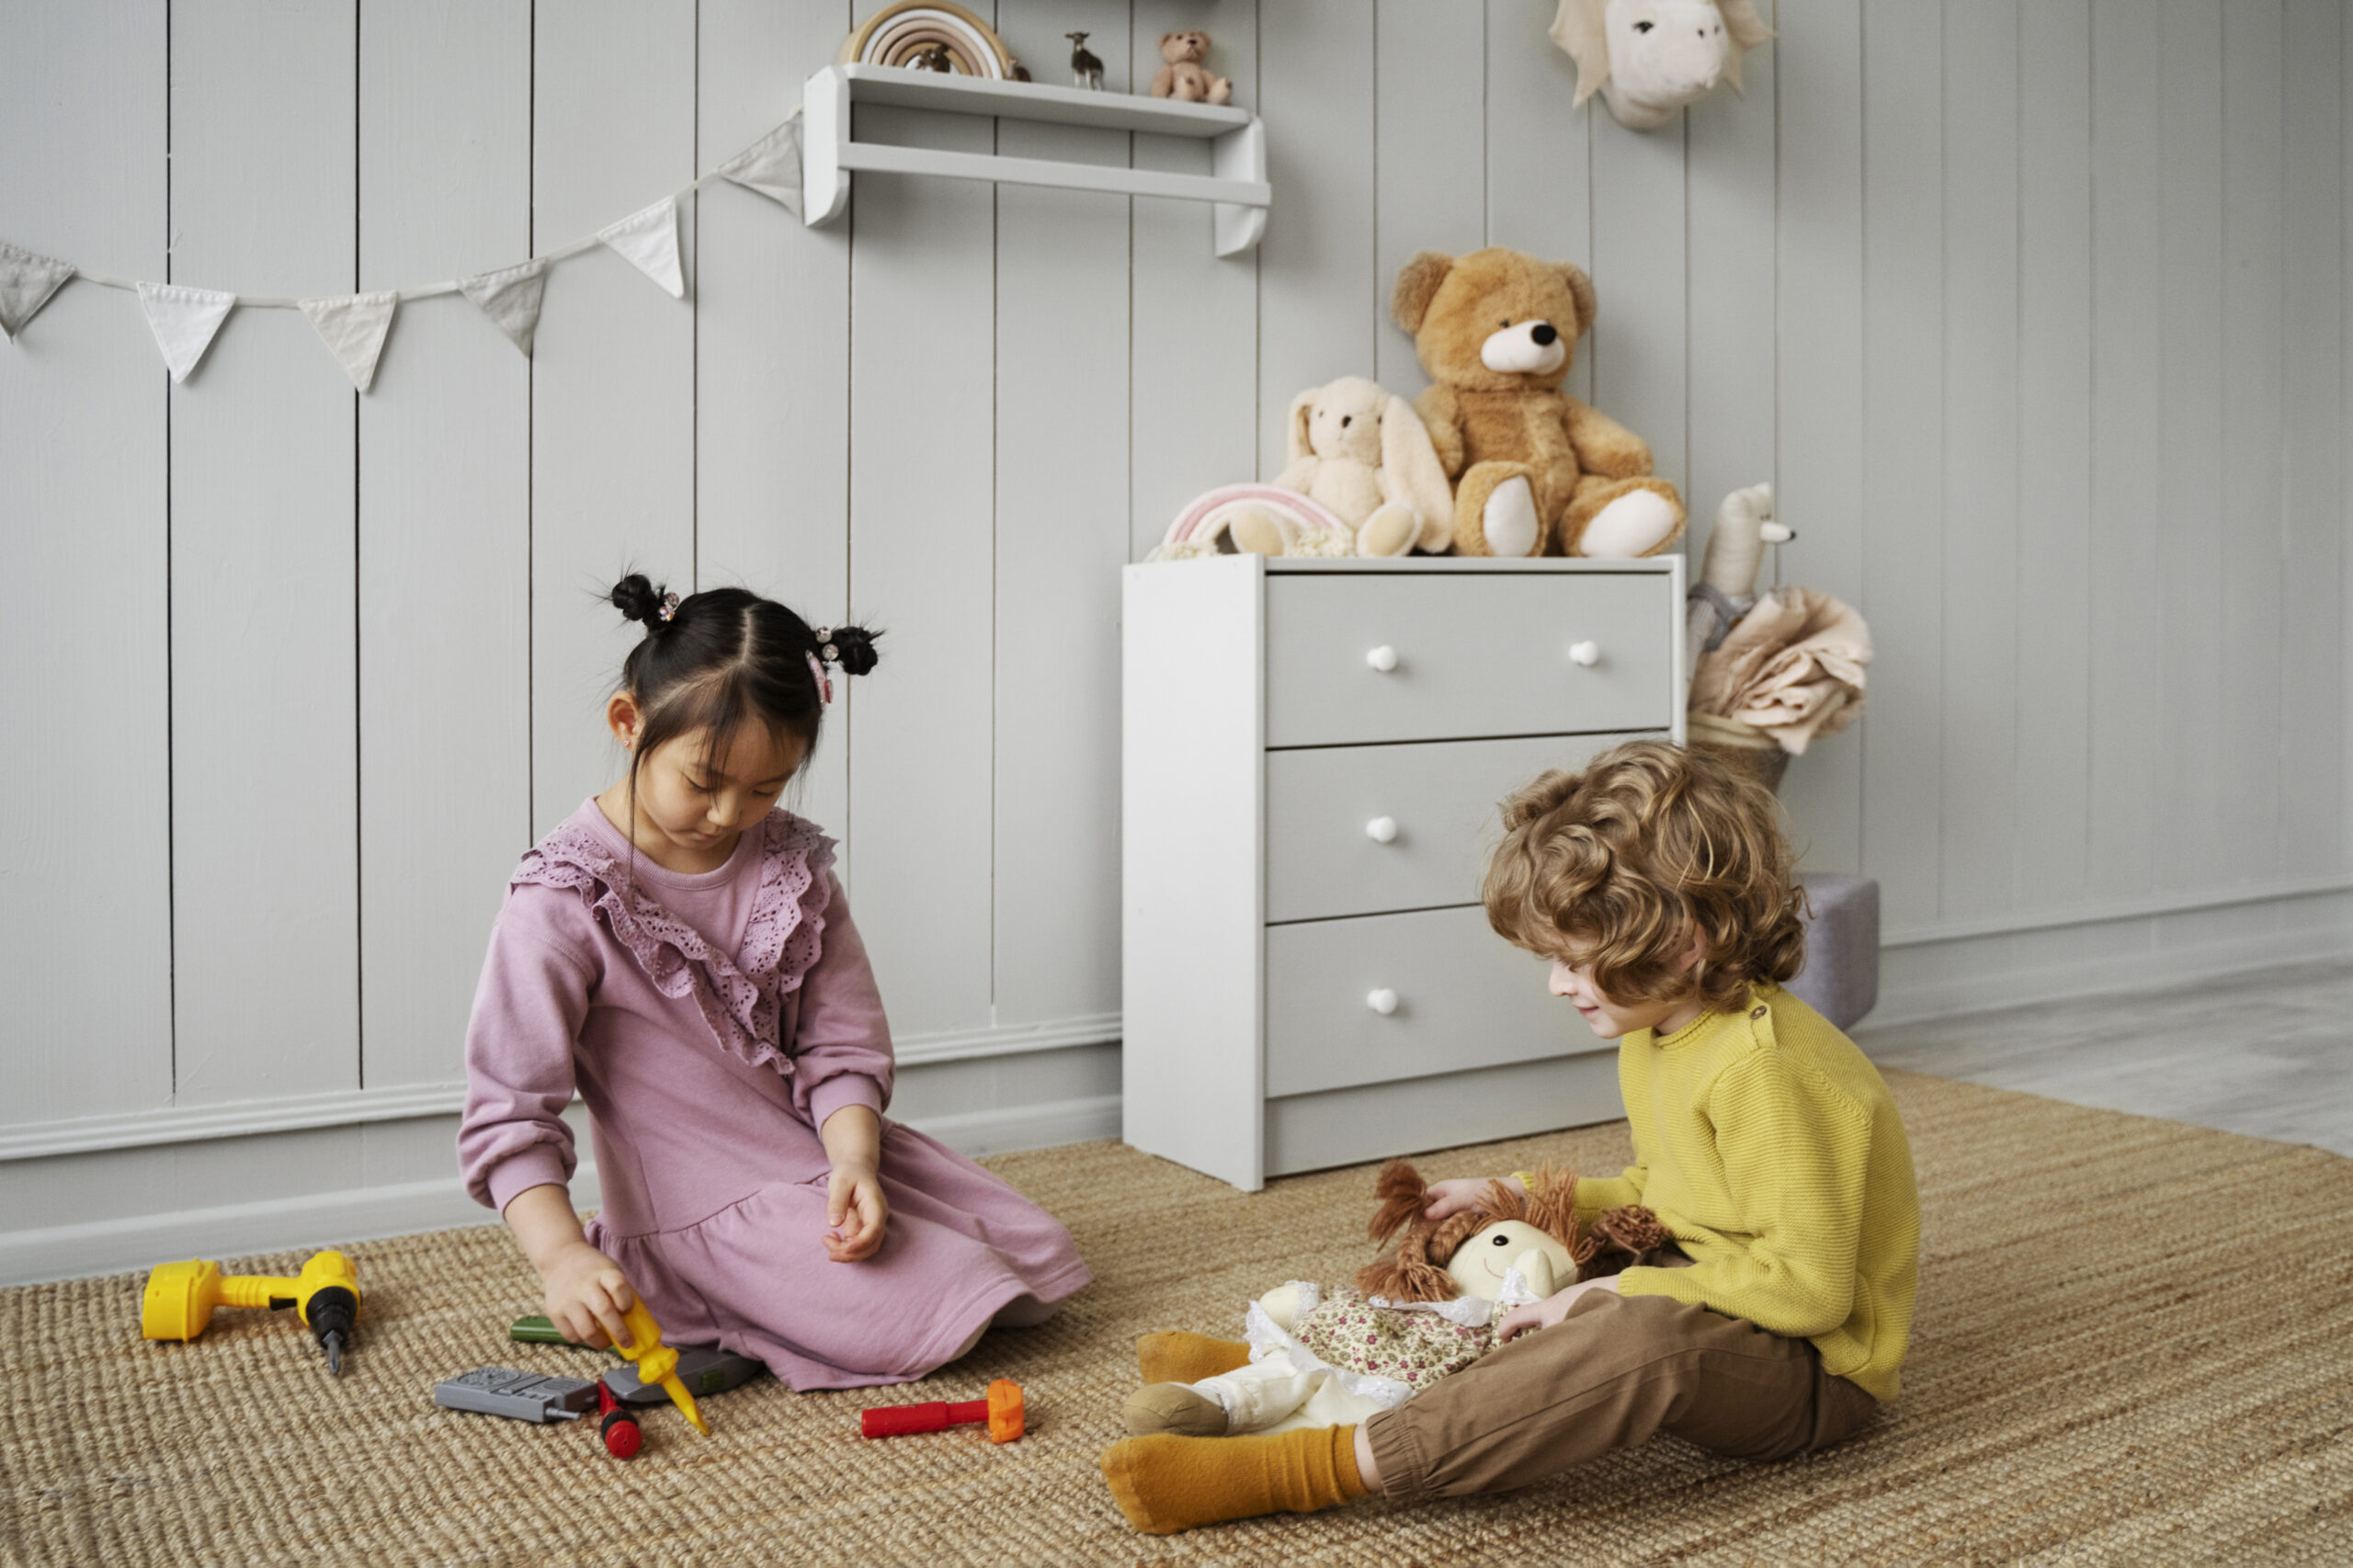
left=0, top=1074, right=2353, bottom=1568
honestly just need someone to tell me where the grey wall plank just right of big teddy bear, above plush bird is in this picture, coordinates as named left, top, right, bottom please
left=1682, top=5, right=1769, bottom=562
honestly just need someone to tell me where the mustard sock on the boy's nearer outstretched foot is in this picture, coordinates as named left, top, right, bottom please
left=1104, top=1426, right=1365, bottom=1535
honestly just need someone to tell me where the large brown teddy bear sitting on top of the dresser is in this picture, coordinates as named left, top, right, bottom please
left=1391, top=247, right=1682, bottom=558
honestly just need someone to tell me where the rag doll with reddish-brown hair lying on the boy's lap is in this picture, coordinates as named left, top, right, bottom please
left=1125, top=1161, right=1682, bottom=1437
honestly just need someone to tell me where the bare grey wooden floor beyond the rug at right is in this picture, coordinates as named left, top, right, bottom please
left=1854, top=959, right=2353, bottom=1153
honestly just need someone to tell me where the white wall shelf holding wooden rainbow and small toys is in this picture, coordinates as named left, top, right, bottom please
left=800, top=66, right=1270, bottom=256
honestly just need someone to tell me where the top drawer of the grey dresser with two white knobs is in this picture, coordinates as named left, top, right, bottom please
left=1266, top=572, right=1676, bottom=746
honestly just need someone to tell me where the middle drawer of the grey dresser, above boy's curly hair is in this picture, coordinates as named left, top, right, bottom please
left=1266, top=734, right=1656, bottom=921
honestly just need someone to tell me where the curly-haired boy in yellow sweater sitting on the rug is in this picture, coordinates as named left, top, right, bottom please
left=1104, top=742, right=1920, bottom=1535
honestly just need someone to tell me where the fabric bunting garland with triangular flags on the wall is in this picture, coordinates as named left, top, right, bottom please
left=0, top=108, right=800, bottom=393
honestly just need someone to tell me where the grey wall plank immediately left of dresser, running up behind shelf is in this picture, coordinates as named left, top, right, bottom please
left=993, top=0, right=1129, bottom=1024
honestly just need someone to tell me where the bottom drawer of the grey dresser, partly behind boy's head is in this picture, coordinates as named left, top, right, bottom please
left=1266, top=904, right=1605, bottom=1095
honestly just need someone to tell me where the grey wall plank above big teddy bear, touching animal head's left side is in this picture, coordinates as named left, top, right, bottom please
left=1477, top=0, right=1607, bottom=400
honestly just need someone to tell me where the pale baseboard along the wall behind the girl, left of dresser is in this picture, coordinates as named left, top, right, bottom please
left=0, top=1095, right=1120, bottom=1286
